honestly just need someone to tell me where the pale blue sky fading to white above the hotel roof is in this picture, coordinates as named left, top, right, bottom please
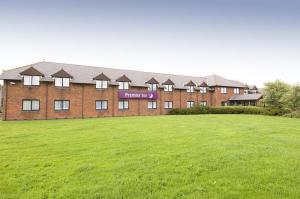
left=0, top=0, right=300, bottom=87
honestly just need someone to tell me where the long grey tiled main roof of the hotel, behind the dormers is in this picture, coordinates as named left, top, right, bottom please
left=0, top=62, right=245, bottom=89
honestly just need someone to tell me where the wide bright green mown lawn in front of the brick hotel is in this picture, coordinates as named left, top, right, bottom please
left=0, top=115, right=300, bottom=199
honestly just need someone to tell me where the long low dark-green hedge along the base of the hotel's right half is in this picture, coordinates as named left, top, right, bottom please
left=169, top=106, right=287, bottom=115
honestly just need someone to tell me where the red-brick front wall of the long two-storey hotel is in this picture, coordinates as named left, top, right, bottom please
left=3, top=80, right=243, bottom=120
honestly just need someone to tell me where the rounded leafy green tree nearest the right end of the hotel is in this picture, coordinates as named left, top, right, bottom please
left=263, top=80, right=290, bottom=109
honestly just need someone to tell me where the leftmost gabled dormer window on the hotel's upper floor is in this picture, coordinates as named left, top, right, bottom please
left=20, top=67, right=44, bottom=86
